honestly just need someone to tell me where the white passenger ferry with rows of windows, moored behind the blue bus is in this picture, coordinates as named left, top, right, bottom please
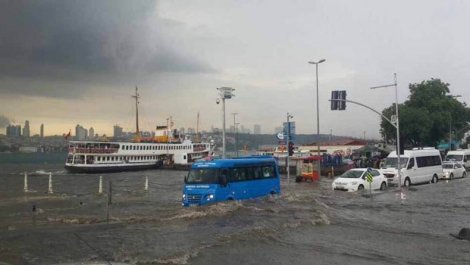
left=65, top=137, right=212, bottom=173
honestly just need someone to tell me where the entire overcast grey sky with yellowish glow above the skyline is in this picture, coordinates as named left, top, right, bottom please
left=0, top=0, right=470, bottom=138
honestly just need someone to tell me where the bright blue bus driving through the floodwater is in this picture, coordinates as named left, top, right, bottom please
left=182, top=156, right=281, bottom=206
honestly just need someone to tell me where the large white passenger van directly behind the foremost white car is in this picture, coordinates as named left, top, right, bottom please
left=381, top=147, right=444, bottom=187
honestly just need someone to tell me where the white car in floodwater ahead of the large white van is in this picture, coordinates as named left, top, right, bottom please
left=331, top=168, right=387, bottom=192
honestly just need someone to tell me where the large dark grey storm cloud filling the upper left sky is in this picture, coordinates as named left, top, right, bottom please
left=0, top=0, right=212, bottom=96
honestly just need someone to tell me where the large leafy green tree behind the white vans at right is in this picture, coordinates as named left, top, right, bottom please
left=380, top=79, right=470, bottom=147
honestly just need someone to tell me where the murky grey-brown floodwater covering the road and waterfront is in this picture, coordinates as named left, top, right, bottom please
left=0, top=154, right=470, bottom=265
